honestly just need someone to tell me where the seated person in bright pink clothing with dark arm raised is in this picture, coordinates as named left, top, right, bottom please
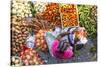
left=51, top=32, right=73, bottom=59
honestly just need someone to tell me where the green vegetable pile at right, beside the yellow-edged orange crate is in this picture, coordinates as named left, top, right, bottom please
left=78, top=5, right=97, bottom=38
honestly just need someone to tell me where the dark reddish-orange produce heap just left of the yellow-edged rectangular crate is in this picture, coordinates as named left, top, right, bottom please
left=42, top=3, right=61, bottom=26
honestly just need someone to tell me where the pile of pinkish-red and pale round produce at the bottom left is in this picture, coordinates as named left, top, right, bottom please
left=20, top=49, right=44, bottom=66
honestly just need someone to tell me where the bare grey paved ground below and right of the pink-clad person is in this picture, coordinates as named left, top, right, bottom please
left=39, top=39, right=97, bottom=64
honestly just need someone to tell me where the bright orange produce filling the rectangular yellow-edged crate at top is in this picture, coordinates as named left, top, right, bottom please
left=60, top=4, right=79, bottom=26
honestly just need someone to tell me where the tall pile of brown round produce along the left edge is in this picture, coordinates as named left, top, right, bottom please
left=11, top=17, right=28, bottom=55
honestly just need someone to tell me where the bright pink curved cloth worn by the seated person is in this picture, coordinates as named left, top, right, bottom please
left=51, top=39, right=73, bottom=59
